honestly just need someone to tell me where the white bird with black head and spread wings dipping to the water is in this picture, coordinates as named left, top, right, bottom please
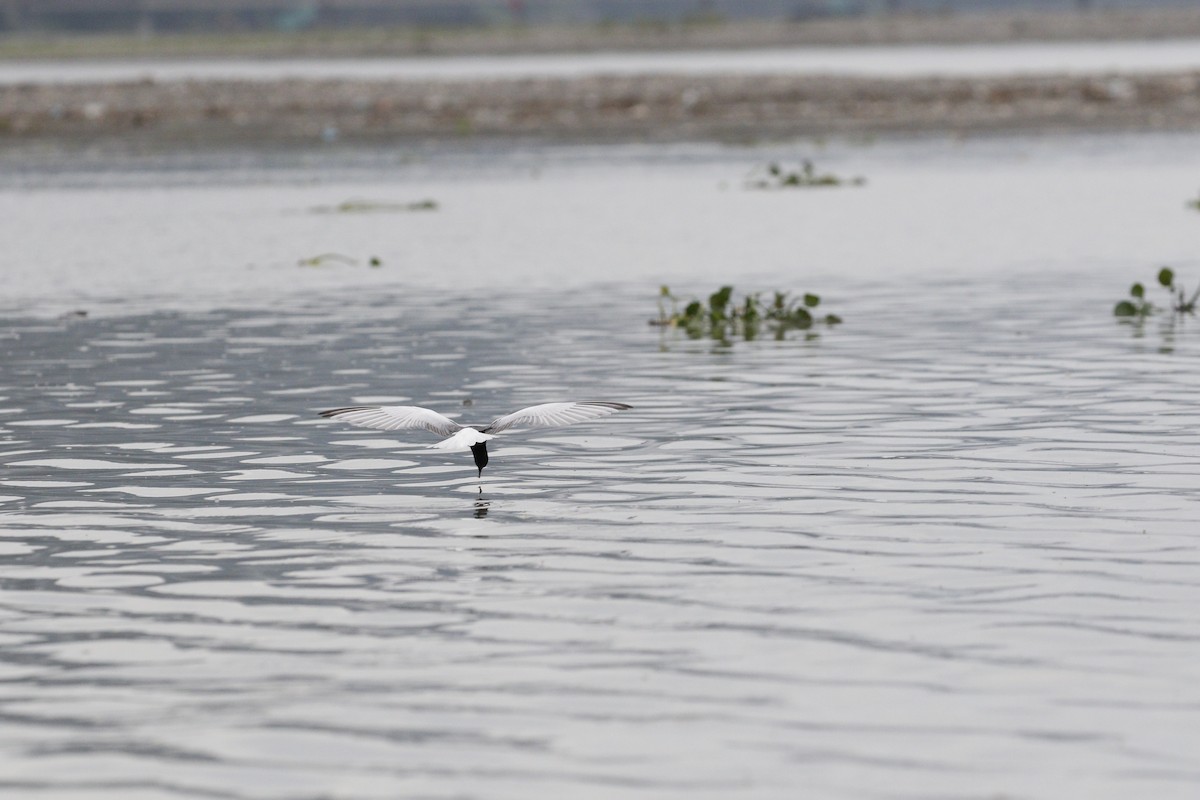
left=320, top=401, right=632, bottom=477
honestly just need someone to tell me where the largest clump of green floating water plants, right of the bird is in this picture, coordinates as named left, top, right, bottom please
left=650, top=287, right=841, bottom=343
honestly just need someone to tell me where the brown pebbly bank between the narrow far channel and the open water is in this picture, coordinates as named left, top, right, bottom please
left=7, top=72, right=1200, bottom=148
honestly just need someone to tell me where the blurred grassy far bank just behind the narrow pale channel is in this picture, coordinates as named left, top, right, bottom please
left=0, top=7, right=1200, bottom=65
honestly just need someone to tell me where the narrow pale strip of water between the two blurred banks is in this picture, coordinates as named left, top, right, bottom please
left=7, top=40, right=1200, bottom=84
